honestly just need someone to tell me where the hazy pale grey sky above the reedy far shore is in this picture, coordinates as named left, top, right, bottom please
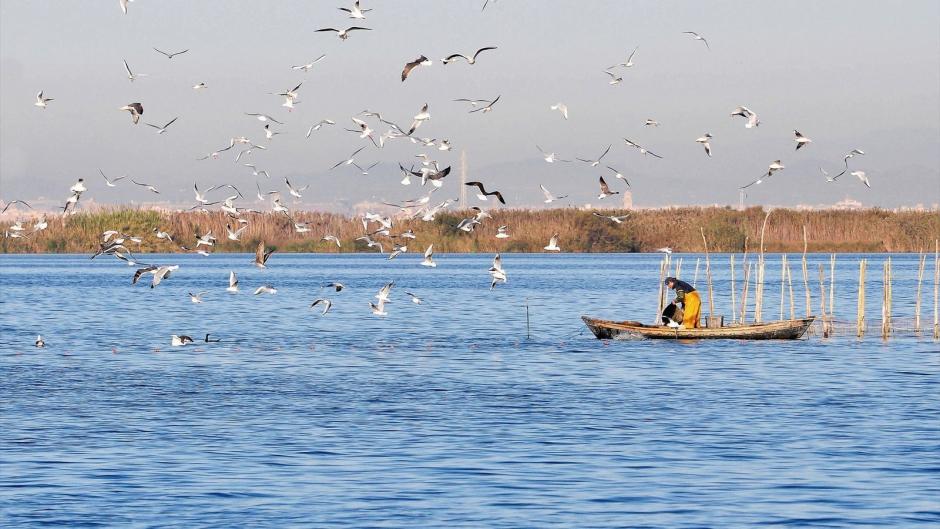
left=0, top=0, right=940, bottom=207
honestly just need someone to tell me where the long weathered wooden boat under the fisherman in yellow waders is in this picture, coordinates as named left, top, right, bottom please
left=581, top=316, right=816, bottom=340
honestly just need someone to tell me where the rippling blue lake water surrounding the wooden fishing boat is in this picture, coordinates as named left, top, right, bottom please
left=0, top=254, right=940, bottom=528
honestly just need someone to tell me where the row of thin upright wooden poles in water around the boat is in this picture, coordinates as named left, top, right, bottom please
left=655, top=212, right=940, bottom=339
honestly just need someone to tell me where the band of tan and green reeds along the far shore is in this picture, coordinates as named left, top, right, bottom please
left=0, top=207, right=940, bottom=253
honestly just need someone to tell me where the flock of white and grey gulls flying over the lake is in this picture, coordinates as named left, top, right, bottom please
left=3, top=0, right=871, bottom=346
